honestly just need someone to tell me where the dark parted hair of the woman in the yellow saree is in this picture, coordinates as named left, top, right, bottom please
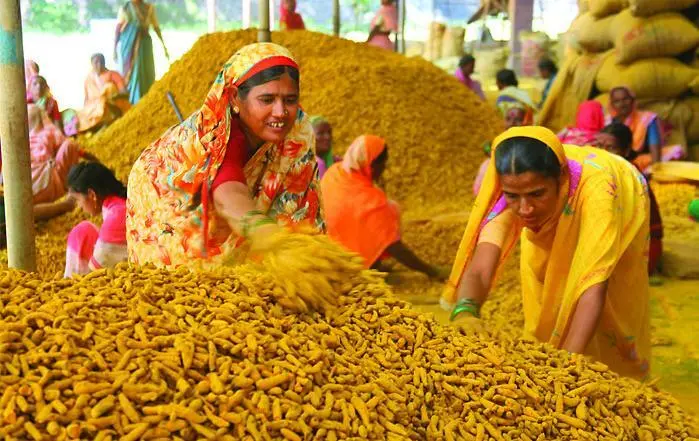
left=495, top=136, right=561, bottom=179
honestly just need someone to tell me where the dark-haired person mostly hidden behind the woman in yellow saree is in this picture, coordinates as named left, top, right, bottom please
left=595, top=121, right=663, bottom=276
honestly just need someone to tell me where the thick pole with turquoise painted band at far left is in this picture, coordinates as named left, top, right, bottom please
left=0, top=0, right=36, bottom=271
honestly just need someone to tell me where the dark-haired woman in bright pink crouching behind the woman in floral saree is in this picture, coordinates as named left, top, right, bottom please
left=64, top=162, right=128, bottom=277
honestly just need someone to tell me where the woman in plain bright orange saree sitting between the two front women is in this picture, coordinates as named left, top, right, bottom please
left=321, top=135, right=445, bottom=279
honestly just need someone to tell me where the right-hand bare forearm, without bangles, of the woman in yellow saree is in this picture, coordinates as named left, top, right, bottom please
left=561, top=282, right=607, bottom=353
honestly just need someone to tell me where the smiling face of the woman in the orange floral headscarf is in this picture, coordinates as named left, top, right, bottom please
left=232, top=73, right=299, bottom=145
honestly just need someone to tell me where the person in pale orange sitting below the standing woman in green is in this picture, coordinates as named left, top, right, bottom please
left=78, top=54, right=131, bottom=132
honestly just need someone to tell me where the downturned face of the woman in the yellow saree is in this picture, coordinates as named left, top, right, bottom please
left=500, top=172, right=558, bottom=230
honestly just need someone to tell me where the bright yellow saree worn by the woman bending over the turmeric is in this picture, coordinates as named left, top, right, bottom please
left=442, top=127, right=650, bottom=377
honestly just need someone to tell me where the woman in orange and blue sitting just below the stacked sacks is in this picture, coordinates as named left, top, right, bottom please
left=605, top=87, right=684, bottom=173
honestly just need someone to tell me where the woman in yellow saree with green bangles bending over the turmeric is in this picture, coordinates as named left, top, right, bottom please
left=442, top=127, right=650, bottom=377
